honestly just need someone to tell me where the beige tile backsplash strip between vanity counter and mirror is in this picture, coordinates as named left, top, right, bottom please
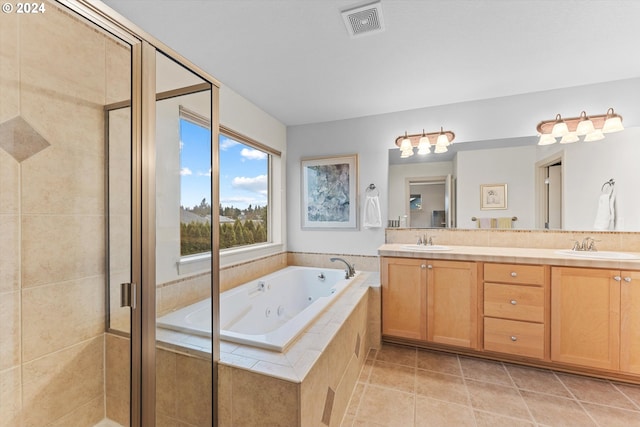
left=385, top=228, right=640, bottom=252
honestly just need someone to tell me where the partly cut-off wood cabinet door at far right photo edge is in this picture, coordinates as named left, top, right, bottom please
left=620, top=271, right=640, bottom=374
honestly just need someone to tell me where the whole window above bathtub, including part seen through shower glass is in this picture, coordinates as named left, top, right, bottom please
left=180, top=108, right=279, bottom=257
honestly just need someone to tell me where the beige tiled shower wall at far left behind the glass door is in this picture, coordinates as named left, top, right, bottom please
left=0, top=2, right=128, bottom=427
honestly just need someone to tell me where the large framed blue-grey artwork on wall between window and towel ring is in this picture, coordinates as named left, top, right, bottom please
left=301, top=154, right=358, bottom=229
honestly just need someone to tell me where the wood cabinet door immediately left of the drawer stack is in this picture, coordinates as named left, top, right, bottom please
left=427, top=260, right=478, bottom=348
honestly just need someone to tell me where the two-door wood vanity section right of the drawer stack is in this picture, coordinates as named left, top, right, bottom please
left=551, top=267, right=640, bottom=374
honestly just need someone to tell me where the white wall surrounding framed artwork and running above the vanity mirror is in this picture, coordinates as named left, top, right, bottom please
left=287, top=78, right=640, bottom=255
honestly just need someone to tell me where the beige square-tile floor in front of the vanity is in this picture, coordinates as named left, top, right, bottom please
left=342, top=344, right=640, bottom=427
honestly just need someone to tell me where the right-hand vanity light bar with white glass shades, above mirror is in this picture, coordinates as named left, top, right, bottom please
left=536, top=108, right=624, bottom=145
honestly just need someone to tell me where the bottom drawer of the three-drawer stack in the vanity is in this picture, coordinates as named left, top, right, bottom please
left=484, top=317, right=544, bottom=359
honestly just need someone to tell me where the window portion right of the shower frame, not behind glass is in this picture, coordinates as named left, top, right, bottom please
left=219, top=130, right=271, bottom=249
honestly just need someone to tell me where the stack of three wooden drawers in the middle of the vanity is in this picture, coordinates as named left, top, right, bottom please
left=483, top=263, right=548, bottom=359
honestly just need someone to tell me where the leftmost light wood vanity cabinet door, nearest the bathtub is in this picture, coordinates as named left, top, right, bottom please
left=381, top=257, right=427, bottom=341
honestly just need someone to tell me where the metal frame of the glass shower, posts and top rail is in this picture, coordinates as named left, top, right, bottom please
left=54, top=0, right=220, bottom=427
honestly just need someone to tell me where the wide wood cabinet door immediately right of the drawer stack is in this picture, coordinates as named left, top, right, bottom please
left=551, top=267, right=620, bottom=369
